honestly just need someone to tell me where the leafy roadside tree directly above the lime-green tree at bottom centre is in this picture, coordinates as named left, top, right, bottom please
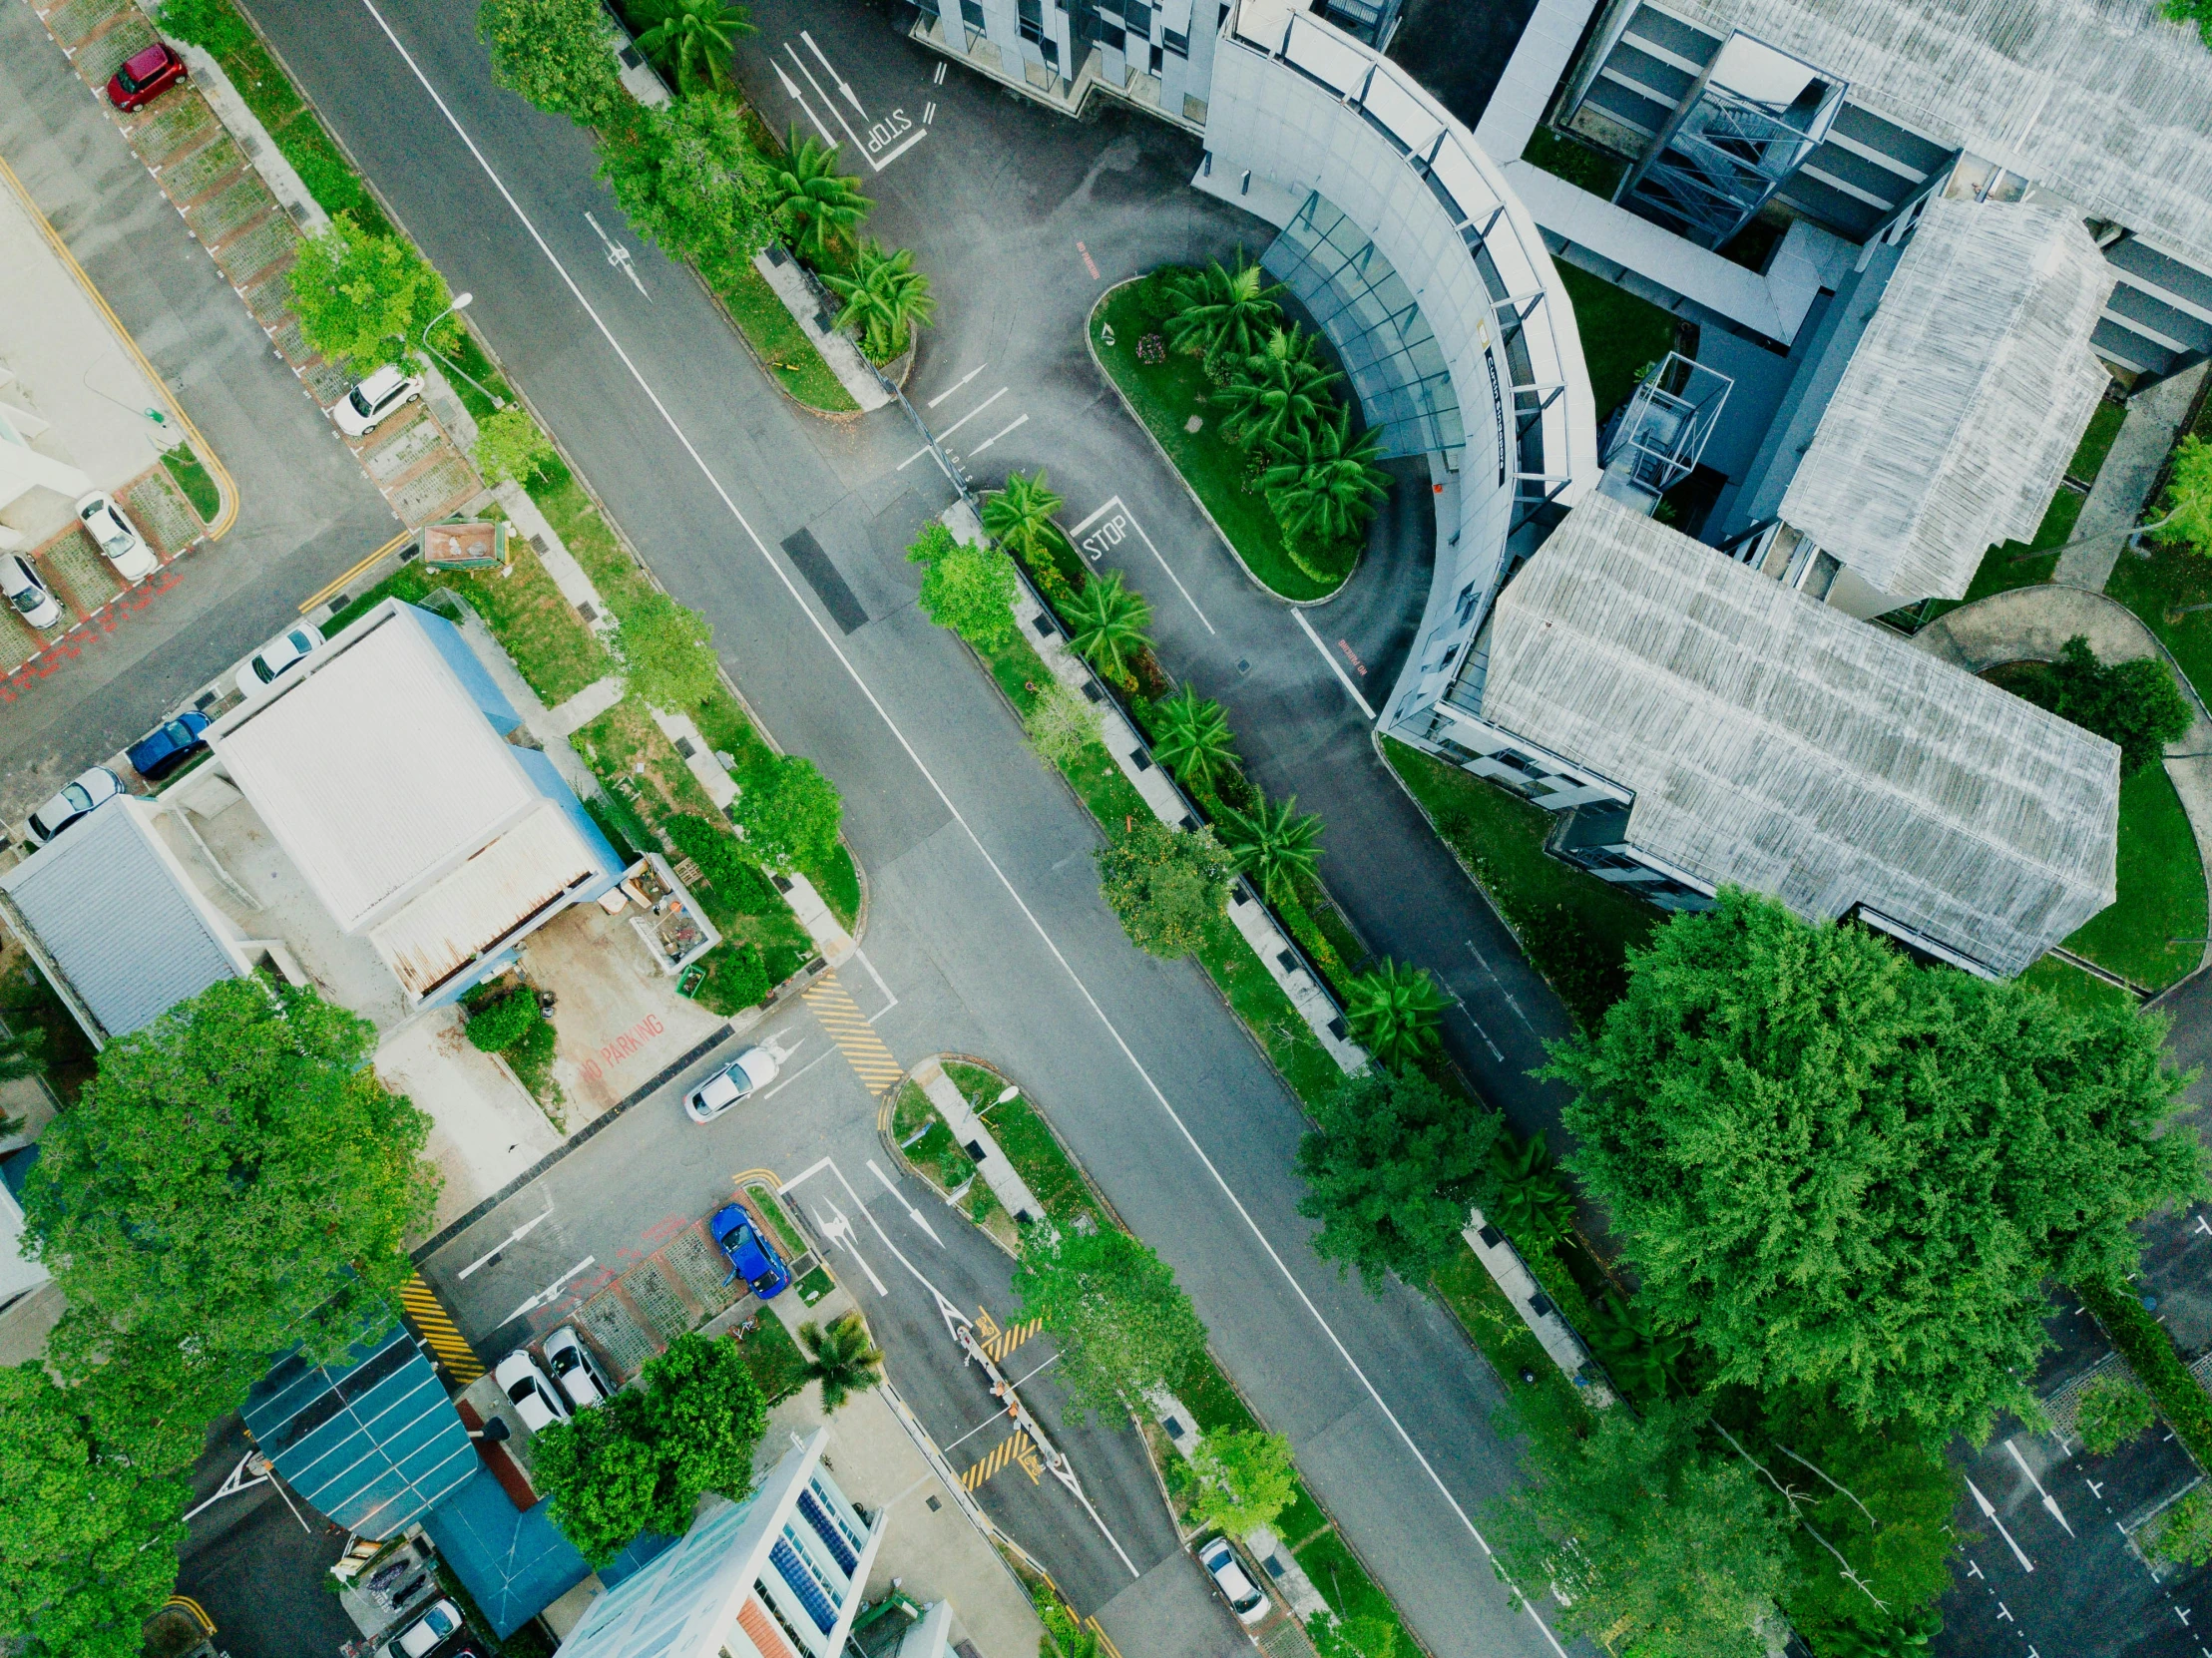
left=1013, top=1227, right=1205, bottom=1417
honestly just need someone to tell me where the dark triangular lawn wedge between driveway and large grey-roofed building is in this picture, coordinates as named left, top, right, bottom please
left=1383, top=740, right=1659, bottom=1031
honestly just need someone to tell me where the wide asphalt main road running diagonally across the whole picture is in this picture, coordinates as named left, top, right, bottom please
left=224, top=0, right=1550, bottom=1658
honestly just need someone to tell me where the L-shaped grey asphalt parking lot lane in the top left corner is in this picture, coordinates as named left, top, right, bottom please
left=0, top=4, right=400, bottom=822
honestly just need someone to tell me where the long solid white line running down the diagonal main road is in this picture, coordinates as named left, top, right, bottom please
left=360, top=19, right=1566, bottom=1658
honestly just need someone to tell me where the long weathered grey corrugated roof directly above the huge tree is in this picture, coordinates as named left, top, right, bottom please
left=1482, top=498, right=2119, bottom=973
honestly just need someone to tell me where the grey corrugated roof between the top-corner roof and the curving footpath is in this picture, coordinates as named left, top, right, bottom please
left=1781, top=197, right=2114, bottom=600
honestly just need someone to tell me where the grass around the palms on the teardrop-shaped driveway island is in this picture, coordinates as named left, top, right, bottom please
left=1091, top=274, right=1358, bottom=600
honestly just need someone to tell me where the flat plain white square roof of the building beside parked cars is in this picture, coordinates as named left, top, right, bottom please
left=211, top=606, right=542, bottom=931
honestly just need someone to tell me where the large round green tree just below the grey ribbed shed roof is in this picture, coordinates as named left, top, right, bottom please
left=24, top=980, right=438, bottom=1366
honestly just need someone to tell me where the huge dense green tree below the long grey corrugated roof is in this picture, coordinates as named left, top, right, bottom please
left=1544, top=891, right=2203, bottom=1435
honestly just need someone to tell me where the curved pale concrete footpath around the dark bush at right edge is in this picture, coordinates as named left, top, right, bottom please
left=1914, top=588, right=2212, bottom=966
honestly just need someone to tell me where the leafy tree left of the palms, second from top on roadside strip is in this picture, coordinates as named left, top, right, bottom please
left=600, top=98, right=774, bottom=263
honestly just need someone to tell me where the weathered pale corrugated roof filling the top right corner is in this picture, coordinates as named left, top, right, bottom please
left=1663, top=0, right=2212, bottom=269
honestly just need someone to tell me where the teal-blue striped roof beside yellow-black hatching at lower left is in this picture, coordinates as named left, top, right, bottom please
left=245, top=1324, right=482, bottom=1536
